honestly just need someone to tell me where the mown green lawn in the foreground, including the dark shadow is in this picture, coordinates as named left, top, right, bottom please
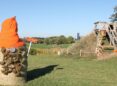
left=26, top=55, right=117, bottom=86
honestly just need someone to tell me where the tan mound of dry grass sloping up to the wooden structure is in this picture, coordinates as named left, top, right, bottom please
left=68, top=32, right=96, bottom=54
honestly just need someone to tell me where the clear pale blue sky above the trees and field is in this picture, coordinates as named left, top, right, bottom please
left=0, top=0, right=117, bottom=37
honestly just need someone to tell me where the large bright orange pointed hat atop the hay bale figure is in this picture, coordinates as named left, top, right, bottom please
left=0, top=17, right=24, bottom=48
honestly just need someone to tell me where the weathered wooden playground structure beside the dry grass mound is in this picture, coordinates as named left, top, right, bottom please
left=94, top=22, right=117, bottom=56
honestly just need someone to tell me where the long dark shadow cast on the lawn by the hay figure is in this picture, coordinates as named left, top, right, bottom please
left=27, top=65, right=58, bottom=81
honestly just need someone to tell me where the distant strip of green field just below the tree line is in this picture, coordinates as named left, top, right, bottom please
left=27, top=43, right=71, bottom=48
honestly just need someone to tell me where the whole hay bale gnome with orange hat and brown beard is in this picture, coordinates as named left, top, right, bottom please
left=0, top=17, right=27, bottom=86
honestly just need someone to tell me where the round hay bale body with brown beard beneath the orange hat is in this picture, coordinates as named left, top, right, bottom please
left=0, top=46, right=27, bottom=86
